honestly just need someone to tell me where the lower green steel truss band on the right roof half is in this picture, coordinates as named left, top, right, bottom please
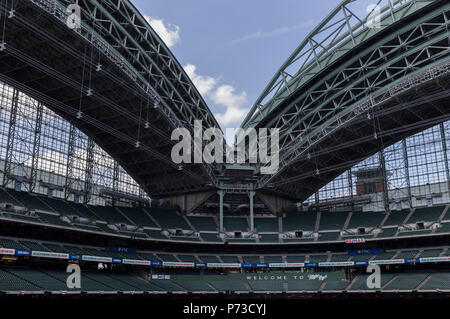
left=258, top=4, right=450, bottom=201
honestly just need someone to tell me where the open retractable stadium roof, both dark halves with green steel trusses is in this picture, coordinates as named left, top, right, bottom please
left=0, top=0, right=450, bottom=201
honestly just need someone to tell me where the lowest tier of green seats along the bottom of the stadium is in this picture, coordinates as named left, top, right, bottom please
left=0, top=266, right=450, bottom=292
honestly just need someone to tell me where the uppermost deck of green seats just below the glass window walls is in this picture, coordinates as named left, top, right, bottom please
left=0, top=189, right=450, bottom=243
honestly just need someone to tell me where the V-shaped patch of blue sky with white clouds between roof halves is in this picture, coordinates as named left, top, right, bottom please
left=128, top=0, right=356, bottom=130
